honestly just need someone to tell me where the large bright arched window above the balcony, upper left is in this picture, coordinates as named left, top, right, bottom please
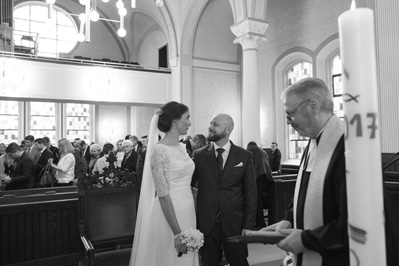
left=14, top=1, right=78, bottom=57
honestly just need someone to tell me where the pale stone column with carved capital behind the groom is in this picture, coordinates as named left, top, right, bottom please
left=231, top=18, right=268, bottom=147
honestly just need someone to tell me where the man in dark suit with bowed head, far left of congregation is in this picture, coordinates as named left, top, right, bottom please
left=3, top=142, right=36, bottom=190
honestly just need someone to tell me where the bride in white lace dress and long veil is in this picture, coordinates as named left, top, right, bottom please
left=130, top=102, right=199, bottom=266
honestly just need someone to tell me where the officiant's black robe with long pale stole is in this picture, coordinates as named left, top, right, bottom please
left=285, top=116, right=349, bottom=266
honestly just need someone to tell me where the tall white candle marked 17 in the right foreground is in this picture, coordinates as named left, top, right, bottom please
left=338, top=1, right=386, bottom=266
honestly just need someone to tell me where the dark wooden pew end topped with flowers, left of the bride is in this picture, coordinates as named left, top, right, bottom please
left=78, top=153, right=139, bottom=266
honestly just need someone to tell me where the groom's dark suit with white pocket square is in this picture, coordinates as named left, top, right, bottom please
left=192, top=143, right=256, bottom=265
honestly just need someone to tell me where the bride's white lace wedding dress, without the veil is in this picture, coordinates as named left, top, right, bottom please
left=131, top=144, right=199, bottom=266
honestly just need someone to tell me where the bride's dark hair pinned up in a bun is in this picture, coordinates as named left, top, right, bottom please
left=158, top=102, right=188, bottom=133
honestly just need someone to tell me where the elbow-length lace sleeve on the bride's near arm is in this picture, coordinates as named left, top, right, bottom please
left=151, top=145, right=169, bottom=197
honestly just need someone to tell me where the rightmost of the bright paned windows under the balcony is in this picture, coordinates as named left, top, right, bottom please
left=66, top=103, right=90, bottom=141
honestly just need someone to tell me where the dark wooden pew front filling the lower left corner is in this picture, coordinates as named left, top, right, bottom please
left=0, top=187, right=79, bottom=266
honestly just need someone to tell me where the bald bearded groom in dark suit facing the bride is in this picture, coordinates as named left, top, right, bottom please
left=192, top=114, right=256, bottom=266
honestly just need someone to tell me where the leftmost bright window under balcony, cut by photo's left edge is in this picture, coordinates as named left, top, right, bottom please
left=0, top=101, right=19, bottom=144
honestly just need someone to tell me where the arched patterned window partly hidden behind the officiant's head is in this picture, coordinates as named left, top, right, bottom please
left=286, top=61, right=313, bottom=159
